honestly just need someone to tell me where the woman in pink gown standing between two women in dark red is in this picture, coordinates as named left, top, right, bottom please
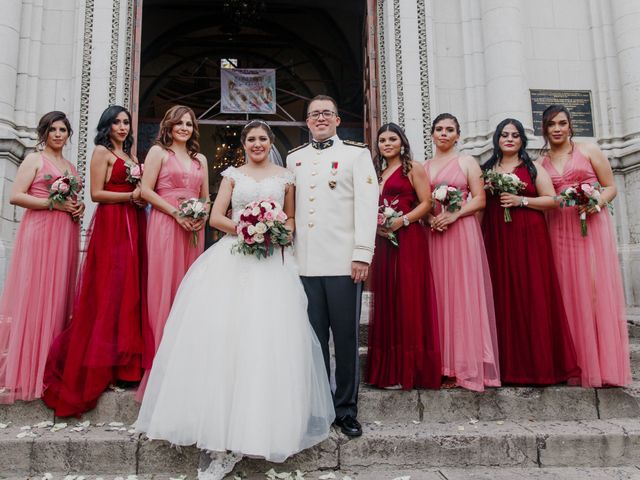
left=425, top=113, right=500, bottom=392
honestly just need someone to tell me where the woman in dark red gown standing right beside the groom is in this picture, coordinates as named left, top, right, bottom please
left=366, top=123, right=442, bottom=390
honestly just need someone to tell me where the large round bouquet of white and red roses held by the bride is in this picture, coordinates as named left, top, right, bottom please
left=232, top=198, right=291, bottom=261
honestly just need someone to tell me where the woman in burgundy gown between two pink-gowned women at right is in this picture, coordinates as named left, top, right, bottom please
left=482, top=118, right=580, bottom=385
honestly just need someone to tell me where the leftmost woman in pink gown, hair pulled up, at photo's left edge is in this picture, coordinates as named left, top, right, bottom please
left=0, top=111, right=84, bottom=403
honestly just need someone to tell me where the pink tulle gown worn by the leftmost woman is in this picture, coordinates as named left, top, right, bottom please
left=0, top=155, right=80, bottom=403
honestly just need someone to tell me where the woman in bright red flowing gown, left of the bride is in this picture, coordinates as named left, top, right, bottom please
left=43, top=106, right=146, bottom=417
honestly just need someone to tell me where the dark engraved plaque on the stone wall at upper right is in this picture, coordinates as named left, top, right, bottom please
left=530, top=90, right=594, bottom=137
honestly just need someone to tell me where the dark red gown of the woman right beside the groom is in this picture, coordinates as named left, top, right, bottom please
left=366, top=168, right=442, bottom=390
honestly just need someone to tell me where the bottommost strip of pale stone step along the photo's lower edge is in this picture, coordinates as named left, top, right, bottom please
left=5, top=467, right=640, bottom=480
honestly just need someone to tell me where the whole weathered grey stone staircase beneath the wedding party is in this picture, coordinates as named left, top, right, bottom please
left=0, top=325, right=640, bottom=480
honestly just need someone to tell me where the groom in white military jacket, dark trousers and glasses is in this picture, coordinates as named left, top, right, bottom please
left=287, top=95, right=378, bottom=437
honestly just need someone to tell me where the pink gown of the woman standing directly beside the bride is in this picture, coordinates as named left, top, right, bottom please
left=136, top=150, right=204, bottom=401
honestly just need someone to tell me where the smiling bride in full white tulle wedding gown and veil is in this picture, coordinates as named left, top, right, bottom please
left=136, top=120, right=334, bottom=479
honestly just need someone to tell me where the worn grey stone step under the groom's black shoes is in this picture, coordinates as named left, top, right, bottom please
left=0, top=418, right=640, bottom=476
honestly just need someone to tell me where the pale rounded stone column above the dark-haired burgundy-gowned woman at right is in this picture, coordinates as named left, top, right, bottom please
left=481, top=0, right=533, bottom=134
